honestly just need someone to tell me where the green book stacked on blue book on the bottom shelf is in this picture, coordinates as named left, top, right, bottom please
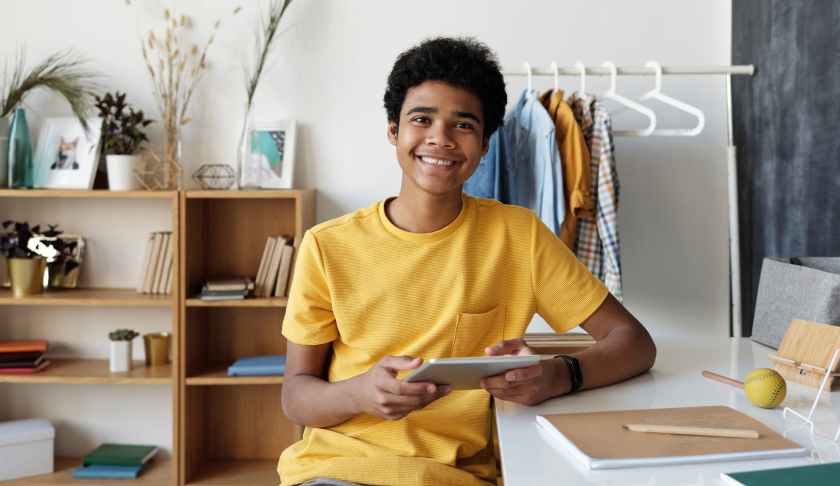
left=73, top=444, right=158, bottom=479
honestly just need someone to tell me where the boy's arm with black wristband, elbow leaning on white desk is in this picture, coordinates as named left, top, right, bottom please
left=484, top=295, right=656, bottom=405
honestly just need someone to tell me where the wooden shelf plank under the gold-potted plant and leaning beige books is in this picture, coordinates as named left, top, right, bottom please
left=0, top=288, right=174, bottom=307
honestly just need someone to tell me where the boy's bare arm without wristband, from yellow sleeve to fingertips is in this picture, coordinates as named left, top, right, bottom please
left=282, top=341, right=449, bottom=427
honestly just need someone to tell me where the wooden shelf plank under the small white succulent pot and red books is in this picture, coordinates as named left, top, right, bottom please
left=0, top=358, right=172, bottom=385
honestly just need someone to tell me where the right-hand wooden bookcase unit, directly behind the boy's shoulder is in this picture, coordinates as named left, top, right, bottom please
left=178, top=190, right=315, bottom=486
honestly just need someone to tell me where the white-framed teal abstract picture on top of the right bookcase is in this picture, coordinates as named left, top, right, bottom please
left=242, top=120, right=297, bottom=189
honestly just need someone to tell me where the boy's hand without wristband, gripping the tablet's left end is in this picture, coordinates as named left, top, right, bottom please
left=354, top=356, right=450, bottom=420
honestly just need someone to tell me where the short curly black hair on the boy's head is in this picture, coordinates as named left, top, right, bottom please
left=384, top=37, right=507, bottom=140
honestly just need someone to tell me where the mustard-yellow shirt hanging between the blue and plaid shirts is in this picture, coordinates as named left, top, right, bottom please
left=540, top=90, right=595, bottom=249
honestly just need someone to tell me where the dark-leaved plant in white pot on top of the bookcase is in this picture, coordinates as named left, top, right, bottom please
left=96, top=91, right=152, bottom=191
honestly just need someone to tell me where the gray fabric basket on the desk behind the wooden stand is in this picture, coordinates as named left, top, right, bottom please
left=752, top=257, right=840, bottom=349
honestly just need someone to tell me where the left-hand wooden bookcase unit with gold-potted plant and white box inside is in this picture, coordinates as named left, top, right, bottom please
left=0, top=189, right=181, bottom=486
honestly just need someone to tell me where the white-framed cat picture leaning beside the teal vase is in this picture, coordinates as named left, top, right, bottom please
left=33, top=117, right=102, bottom=189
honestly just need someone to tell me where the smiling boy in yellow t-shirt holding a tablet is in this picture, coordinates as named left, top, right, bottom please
left=279, top=38, right=655, bottom=486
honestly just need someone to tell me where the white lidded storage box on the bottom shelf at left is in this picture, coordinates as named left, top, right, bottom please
left=0, top=419, right=55, bottom=481
